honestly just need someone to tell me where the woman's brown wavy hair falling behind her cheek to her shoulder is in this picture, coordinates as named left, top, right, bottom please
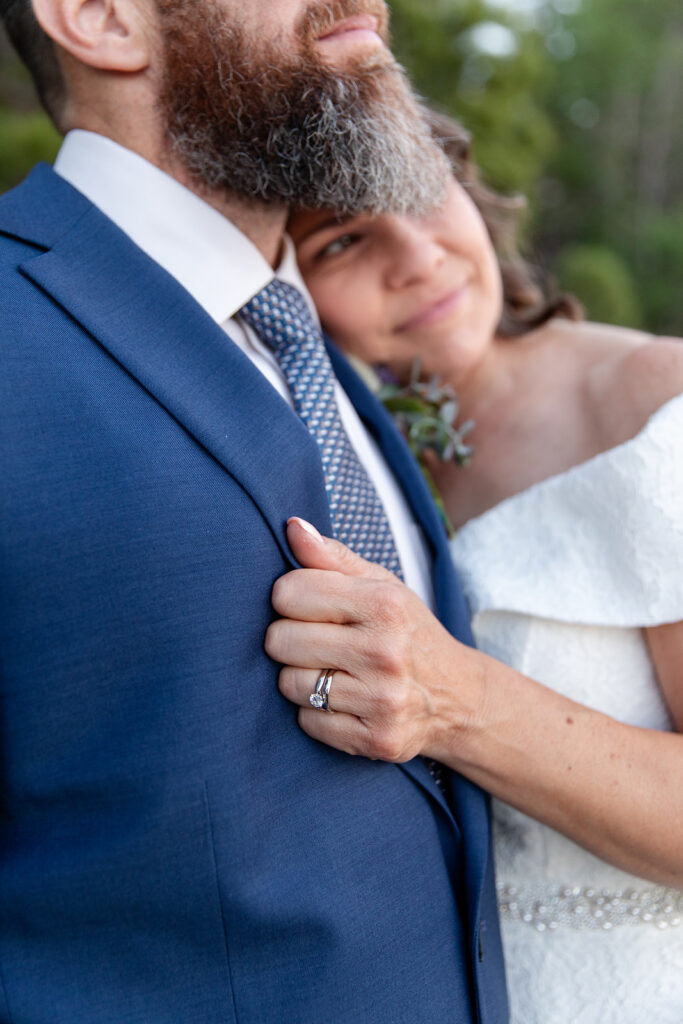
left=430, top=113, right=584, bottom=338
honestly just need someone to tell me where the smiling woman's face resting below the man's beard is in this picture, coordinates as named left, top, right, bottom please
left=290, top=179, right=503, bottom=384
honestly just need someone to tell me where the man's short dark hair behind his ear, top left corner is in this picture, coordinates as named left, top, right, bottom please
left=0, top=0, right=66, bottom=128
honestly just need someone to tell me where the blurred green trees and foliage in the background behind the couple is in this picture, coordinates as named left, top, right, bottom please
left=0, top=0, right=683, bottom=334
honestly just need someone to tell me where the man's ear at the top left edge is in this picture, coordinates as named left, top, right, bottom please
left=33, top=0, right=154, bottom=73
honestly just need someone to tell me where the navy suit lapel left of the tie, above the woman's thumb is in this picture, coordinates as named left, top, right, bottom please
left=14, top=174, right=331, bottom=561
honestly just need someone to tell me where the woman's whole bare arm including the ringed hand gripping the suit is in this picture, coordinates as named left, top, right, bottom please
left=266, top=520, right=683, bottom=887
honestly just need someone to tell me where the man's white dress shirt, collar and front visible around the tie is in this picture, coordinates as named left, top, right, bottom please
left=54, top=130, right=433, bottom=607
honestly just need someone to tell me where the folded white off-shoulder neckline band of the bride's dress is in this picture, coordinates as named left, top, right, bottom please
left=451, top=394, right=683, bottom=628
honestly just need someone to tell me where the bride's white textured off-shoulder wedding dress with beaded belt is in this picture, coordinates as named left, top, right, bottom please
left=453, top=395, right=683, bottom=1024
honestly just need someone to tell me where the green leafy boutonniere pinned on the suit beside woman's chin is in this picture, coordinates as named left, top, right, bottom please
left=354, top=358, right=474, bottom=537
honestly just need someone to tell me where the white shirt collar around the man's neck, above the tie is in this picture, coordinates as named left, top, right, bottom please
left=54, top=129, right=290, bottom=324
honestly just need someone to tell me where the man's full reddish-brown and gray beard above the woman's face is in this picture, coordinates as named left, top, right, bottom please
left=161, top=12, right=450, bottom=216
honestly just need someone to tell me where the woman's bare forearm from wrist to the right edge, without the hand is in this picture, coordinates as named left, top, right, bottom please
left=432, top=624, right=683, bottom=888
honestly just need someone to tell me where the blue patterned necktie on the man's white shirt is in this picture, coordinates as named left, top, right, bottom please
left=240, top=281, right=402, bottom=579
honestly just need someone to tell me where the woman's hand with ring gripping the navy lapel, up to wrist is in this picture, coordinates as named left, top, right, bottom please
left=265, top=519, right=481, bottom=762
